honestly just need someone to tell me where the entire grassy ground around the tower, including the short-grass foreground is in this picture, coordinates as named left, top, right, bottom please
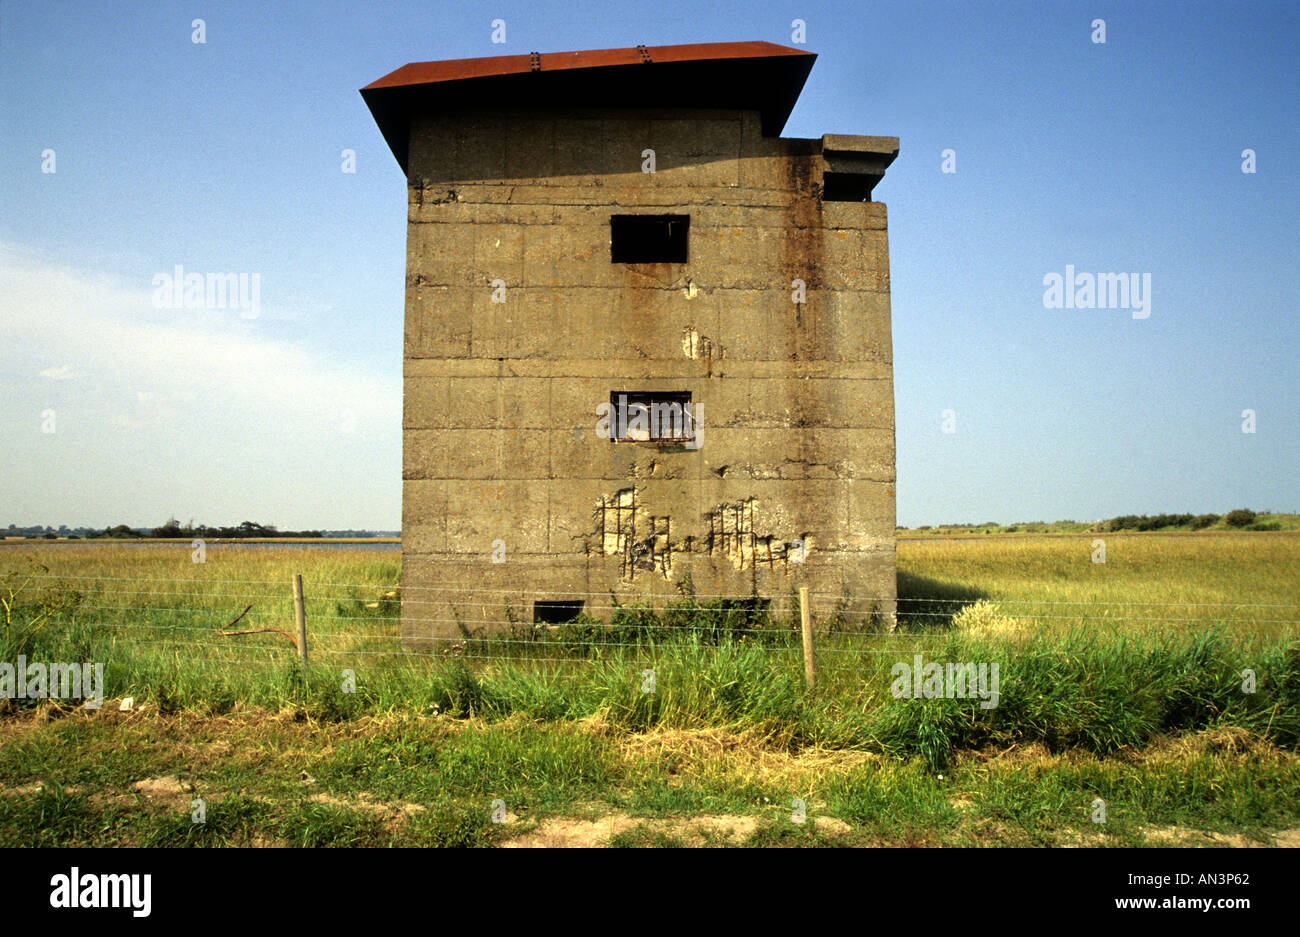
left=0, top=530, right=1300, bottom=846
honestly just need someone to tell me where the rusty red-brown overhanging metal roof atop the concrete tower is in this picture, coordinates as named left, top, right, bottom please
left=361, top=42, right=816, bottom=172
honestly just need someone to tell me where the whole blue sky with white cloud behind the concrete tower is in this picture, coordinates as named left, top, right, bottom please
left=0, top=0, right=1300, bottom=529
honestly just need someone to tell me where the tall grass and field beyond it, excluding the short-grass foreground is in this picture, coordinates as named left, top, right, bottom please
left=0, top=534, right=1300, bottom=767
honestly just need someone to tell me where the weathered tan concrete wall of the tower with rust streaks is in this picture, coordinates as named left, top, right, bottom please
left=402, top=103, right=896, bottom=645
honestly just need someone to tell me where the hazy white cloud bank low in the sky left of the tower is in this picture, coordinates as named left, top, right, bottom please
left=0, top=242, right=402, bottom=529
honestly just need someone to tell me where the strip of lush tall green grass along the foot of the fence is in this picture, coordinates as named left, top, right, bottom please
left=12, top=610, right=1300, bottom=768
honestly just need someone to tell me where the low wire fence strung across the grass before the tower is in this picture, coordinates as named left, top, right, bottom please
left=4, top=573, right=1300, bottom=672
